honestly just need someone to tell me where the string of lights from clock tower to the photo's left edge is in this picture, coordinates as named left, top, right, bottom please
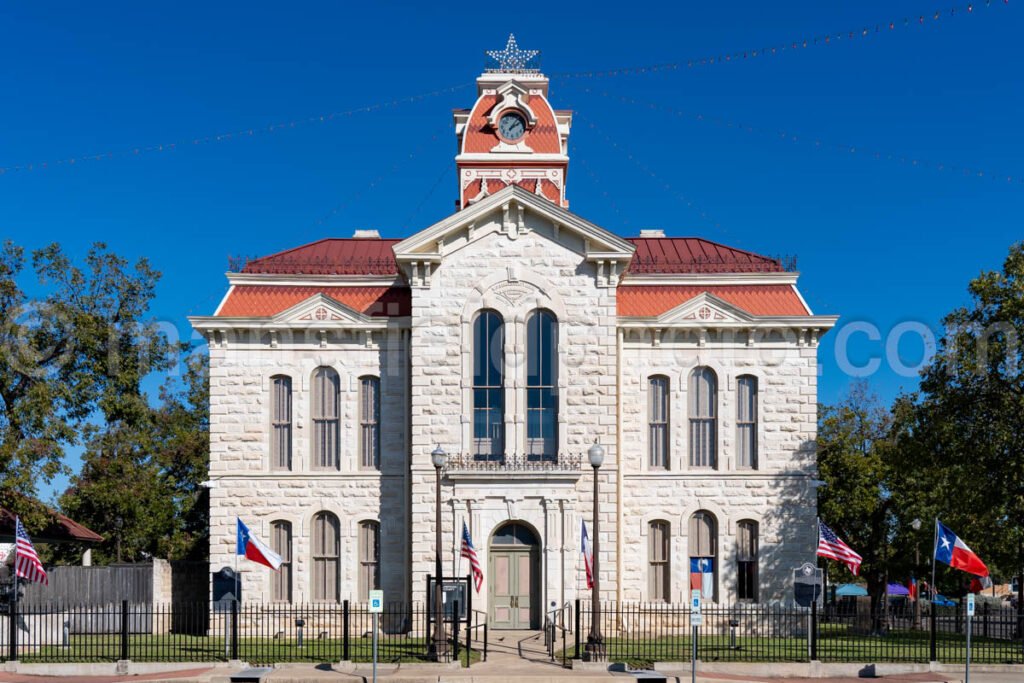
left=0, top=83, right=473, bottom=176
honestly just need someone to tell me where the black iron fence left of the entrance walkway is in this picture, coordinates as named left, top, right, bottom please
left=0, top=600, right=485, bottom=666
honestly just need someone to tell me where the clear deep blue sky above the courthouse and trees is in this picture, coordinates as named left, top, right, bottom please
left=0, top=0, right=1024, bottom=499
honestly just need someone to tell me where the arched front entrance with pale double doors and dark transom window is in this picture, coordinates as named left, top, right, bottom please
left=487, top=522, right=541, bottom=629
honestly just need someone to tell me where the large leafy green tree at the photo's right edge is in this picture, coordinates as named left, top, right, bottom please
left=896, top=243, right=1024, bottom=626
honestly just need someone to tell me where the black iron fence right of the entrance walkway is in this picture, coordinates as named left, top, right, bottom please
left=564, top=600, right=1024, bottom=666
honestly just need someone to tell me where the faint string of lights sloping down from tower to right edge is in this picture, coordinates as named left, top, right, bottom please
left=582, top=87, right=1024, bottom=189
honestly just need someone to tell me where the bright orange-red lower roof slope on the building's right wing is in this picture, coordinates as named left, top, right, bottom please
left=616, top=285, right=810, bottom=317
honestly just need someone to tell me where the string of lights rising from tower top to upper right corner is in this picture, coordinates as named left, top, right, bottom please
left=551, top=0, right=1010, bottom=80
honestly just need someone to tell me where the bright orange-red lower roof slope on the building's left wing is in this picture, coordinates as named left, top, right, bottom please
left=217, top=285, right=412, bottom=317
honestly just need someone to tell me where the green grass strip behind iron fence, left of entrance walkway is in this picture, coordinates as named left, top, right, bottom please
left=20, top=635, right=480, bottom=666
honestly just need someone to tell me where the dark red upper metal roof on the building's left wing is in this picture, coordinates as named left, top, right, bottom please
left=242, top=238, right=401, bottom=275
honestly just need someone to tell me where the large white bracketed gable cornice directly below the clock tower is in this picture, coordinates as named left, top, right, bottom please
left=394, top=185, right=636, bottom=283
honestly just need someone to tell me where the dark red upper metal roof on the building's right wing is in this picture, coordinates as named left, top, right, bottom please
left=626, top=238, right=784, bottom=274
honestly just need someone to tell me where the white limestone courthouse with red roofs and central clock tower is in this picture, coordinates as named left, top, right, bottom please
left=191, top=42, right=836, bottom=629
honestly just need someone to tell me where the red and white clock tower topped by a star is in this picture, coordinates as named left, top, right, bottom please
left=455, top=35, right=572, bottom=210
